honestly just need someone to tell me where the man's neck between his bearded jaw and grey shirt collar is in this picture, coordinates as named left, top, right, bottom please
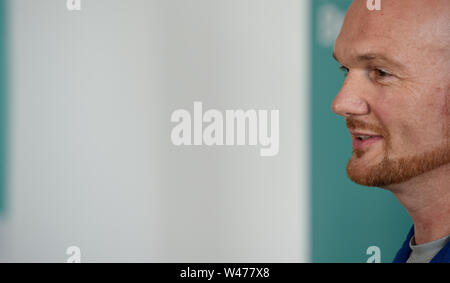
left=386, top=164, right=450, bottom=245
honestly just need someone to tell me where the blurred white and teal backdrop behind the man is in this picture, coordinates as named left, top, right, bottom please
left=0, top=0, right=411, bottom=262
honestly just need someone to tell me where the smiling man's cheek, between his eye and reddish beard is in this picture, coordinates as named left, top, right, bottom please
left=371, top=79, right=450, bottom=153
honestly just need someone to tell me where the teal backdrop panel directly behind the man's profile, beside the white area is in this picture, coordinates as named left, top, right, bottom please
left=310, top=0, right=412, bottom=262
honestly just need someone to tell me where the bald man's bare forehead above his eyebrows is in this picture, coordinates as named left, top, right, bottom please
left=335, top=0, right=450, bottom=66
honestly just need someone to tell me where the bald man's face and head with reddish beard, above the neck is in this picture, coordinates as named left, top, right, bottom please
left=332, top=0, right=450, bottom=191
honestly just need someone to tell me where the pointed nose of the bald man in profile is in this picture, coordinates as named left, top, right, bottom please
left=331, top=73, right=370, bottom=117
